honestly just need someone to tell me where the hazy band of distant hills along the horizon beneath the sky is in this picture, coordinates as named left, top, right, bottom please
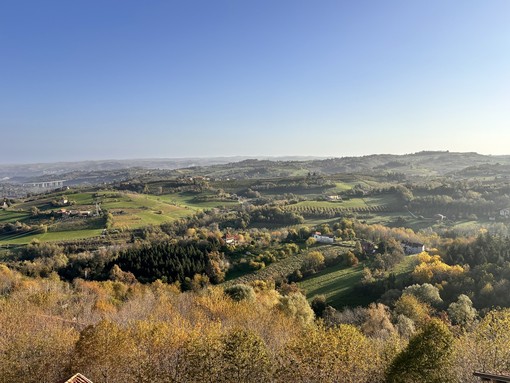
left=0, top=151, right=510, bottom=184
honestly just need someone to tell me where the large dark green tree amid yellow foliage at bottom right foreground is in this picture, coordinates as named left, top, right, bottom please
left=386, top=319, right=454, bottom=383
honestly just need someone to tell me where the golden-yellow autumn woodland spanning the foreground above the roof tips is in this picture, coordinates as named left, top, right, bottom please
left=0, top=266, right=510, bottom=383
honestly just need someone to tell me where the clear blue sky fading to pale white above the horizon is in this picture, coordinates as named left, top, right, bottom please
left=0, top=0, right=510, bottom=164
